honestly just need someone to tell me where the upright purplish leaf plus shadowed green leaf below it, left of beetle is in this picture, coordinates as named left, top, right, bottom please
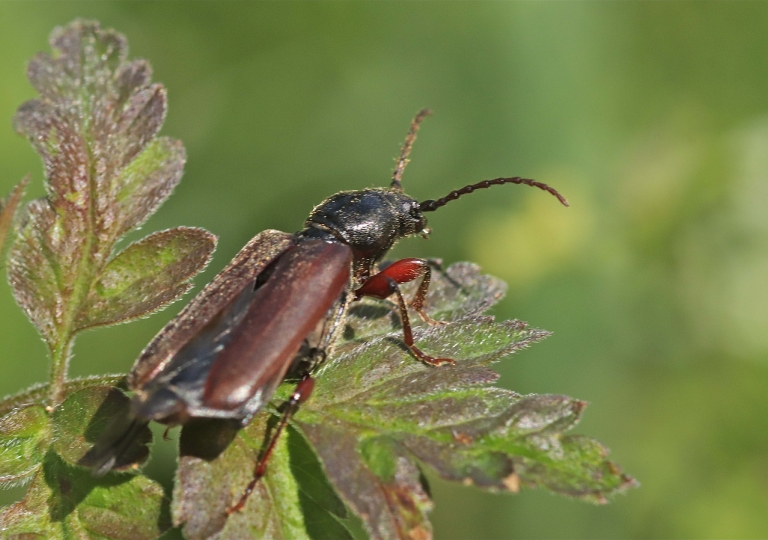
left=0, top=21, right=216, bottom=539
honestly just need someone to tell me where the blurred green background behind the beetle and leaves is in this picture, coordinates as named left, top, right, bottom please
left=0, top=2, right=768, bottom=539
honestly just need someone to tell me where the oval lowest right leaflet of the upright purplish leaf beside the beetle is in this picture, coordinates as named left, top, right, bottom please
left=77, top=227, right=216, bottom=329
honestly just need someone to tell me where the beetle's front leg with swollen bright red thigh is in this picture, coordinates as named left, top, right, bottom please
left=355, top=258, right=446, bottom=326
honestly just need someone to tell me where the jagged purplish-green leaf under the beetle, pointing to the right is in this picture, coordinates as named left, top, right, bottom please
left=174, top=263, right=634, bottom=540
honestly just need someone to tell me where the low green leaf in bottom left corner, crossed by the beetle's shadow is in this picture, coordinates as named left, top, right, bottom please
left=0, top=384, right=164, bottom=539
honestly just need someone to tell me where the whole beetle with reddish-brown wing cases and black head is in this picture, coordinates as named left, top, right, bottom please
left=91, top=109, right=568, bottom=513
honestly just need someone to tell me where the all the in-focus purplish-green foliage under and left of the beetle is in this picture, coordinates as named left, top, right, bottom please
left=0, top=21, right=635, bottom=540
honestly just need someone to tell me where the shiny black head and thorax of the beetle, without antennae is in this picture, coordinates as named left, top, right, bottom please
left=305, top=188, right=427, bottom=262
